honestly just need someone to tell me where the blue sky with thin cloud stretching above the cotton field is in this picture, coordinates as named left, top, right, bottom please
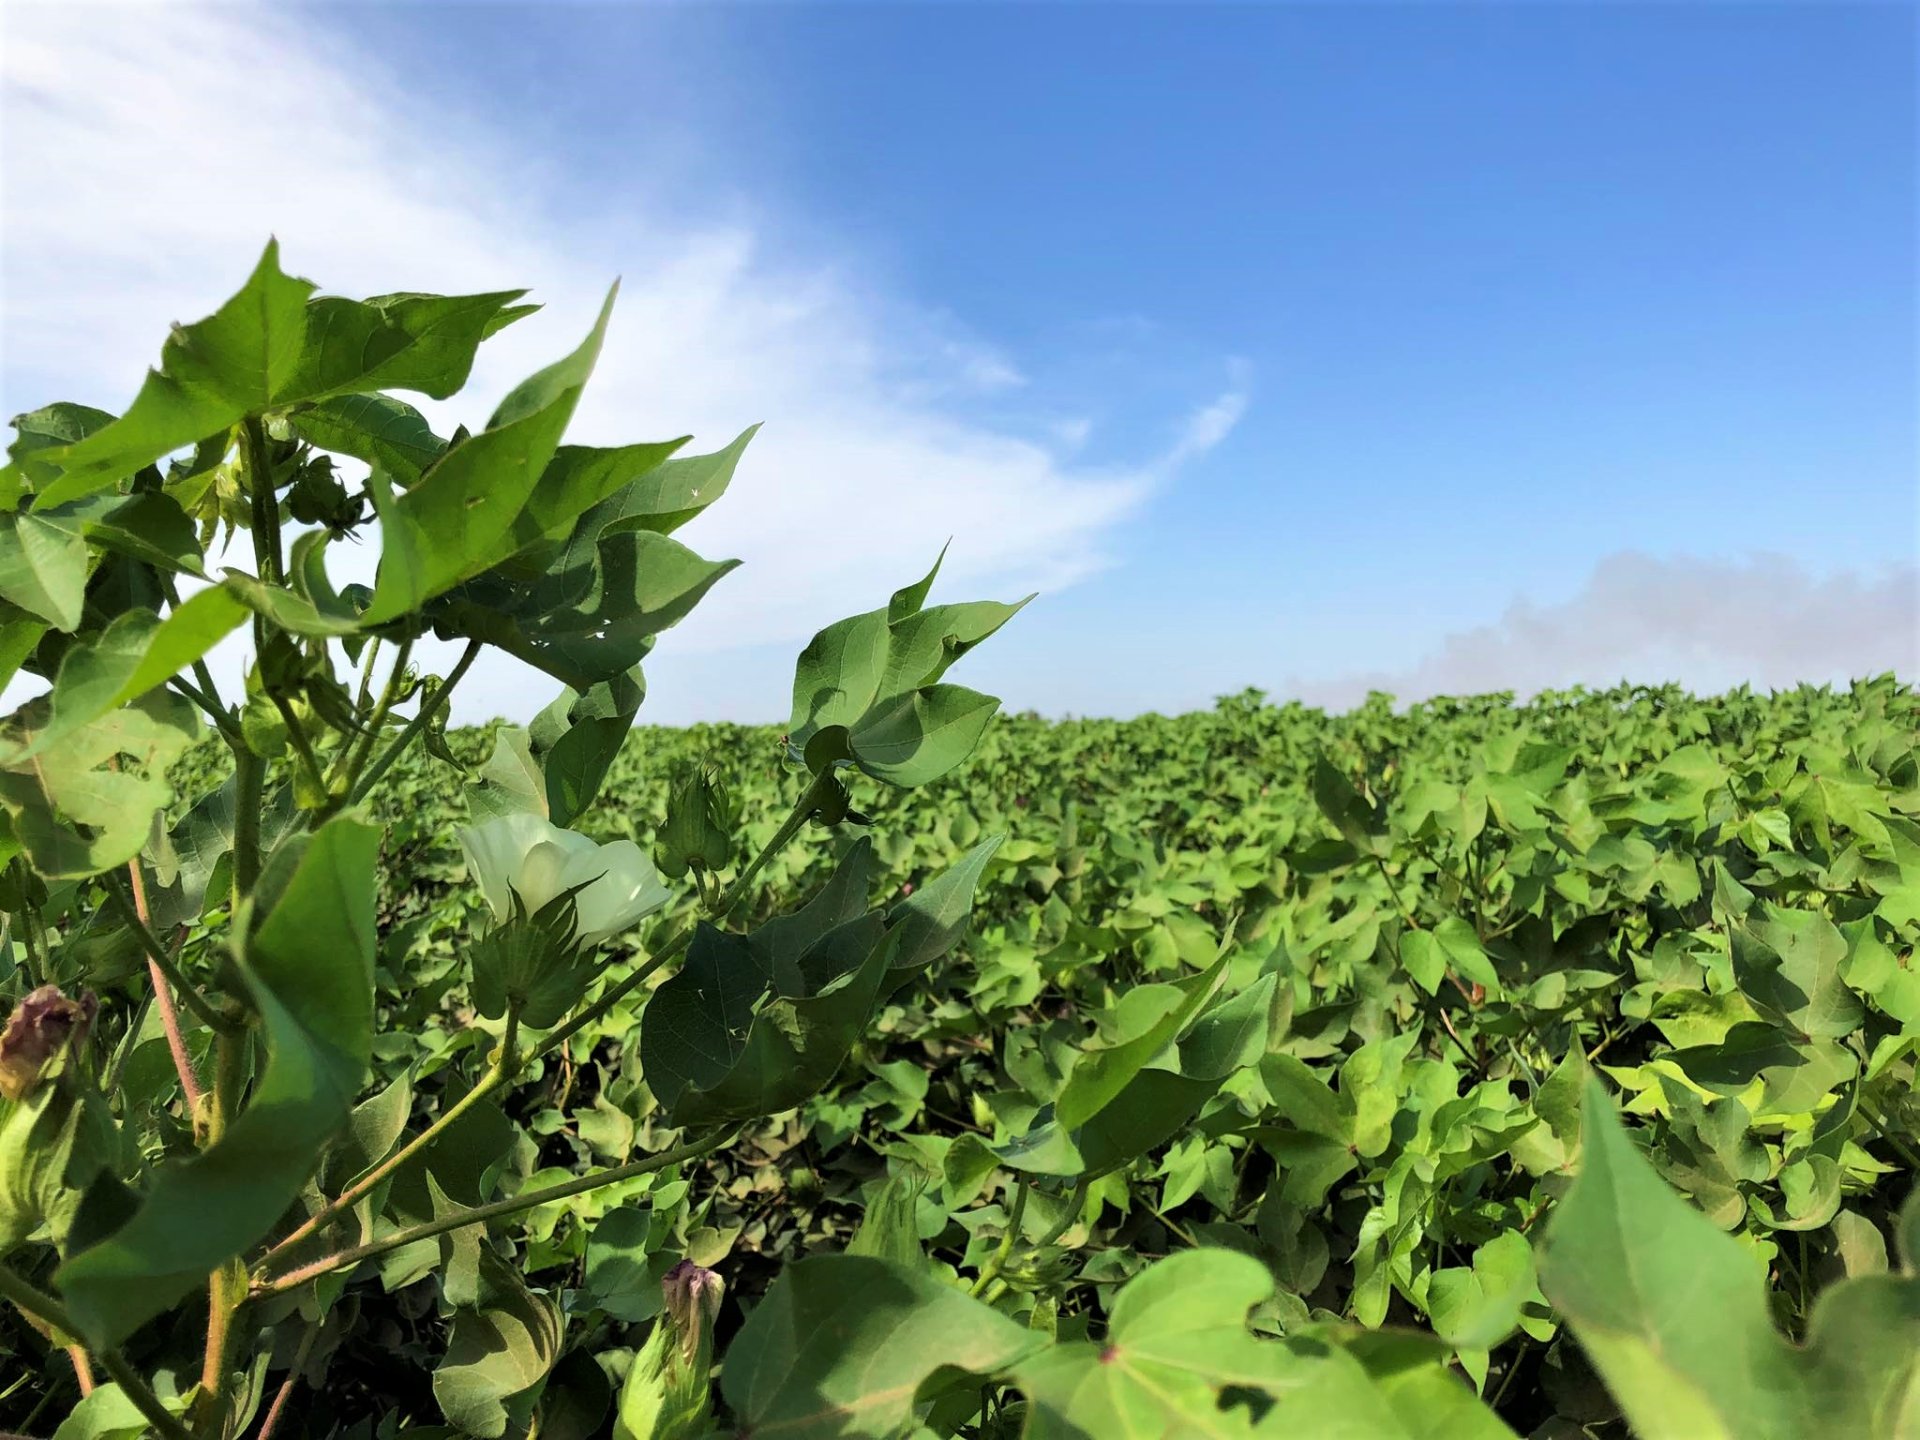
left=4, top=4, right=1920, bottom=720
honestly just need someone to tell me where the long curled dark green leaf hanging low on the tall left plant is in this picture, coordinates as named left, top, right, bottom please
left=54, top=816, right=380, bottom=1346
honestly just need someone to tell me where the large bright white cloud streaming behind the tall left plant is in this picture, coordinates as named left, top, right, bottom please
left=0, top=4, right=1244, bottom=718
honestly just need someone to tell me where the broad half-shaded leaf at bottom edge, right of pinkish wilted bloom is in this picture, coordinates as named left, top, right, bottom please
left=720, top=1256, right=1043, bottom=1440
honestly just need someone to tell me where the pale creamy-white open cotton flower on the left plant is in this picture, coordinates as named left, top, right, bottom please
left=461, top=814, right=674, bottom=945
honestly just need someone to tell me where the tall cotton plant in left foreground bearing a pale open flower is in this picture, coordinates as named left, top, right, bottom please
left=0, top=244, right=1018, bottom=1440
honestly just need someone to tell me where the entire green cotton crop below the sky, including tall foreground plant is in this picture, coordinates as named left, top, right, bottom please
left=0, top=246, right=1920, bottom=1440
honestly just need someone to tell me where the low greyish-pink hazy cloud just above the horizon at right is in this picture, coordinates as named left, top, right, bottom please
left=1281, top=551, right=1920, bottom=708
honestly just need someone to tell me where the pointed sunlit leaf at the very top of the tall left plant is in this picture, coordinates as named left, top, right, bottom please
left=35, top=240, right=313, bottom=509
